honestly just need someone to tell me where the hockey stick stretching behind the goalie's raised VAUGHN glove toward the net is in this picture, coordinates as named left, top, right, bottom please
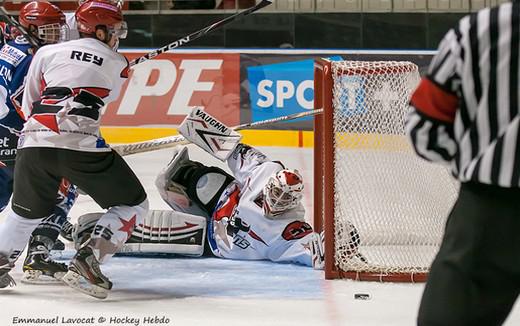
left=112, top=109, right=323, bottom=156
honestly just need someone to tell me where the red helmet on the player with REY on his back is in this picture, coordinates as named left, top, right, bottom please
left=76, top=0, right=127, bottom=38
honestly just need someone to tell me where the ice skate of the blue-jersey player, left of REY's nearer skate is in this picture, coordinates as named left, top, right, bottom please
left=22, top=235, right=67, bottom=284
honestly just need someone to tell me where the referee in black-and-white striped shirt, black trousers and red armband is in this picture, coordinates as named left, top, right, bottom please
left=406, top=1, right=520, bottom=326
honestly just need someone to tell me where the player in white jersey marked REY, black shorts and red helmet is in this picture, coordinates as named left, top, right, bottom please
left=0, top=1, right=148, bottom=298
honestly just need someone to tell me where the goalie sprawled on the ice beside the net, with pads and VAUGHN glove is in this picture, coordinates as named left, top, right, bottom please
left=71, top=109, right=330, bottom=268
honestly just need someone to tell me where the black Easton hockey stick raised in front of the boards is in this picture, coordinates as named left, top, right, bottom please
left=130, top=0, right=272, bottom=67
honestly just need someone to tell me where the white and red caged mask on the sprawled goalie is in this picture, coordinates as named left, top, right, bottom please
left=262, top=169, right=303, bottom=217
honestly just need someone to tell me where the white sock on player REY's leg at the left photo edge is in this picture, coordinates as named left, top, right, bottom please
left=0, top=209, right=42, bottom=261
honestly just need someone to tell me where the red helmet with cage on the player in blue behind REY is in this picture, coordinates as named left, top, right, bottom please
left=18, top=1, right=67, bottom=43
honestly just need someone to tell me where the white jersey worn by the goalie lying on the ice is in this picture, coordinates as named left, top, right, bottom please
left=208, top=144, right=313, bottom=266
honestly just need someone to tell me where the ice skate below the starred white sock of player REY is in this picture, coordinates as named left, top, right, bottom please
left=62, top=240, right=112, bottom=299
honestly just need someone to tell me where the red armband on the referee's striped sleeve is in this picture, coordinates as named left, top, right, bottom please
left=410, top=78, right=459, bottom=122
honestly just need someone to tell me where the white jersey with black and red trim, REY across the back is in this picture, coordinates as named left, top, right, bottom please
left=18, top=38, right=129, bottom=152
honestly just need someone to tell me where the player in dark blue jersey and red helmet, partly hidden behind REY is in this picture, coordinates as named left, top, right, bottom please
left=0, top=1, right=77, bottom=282
